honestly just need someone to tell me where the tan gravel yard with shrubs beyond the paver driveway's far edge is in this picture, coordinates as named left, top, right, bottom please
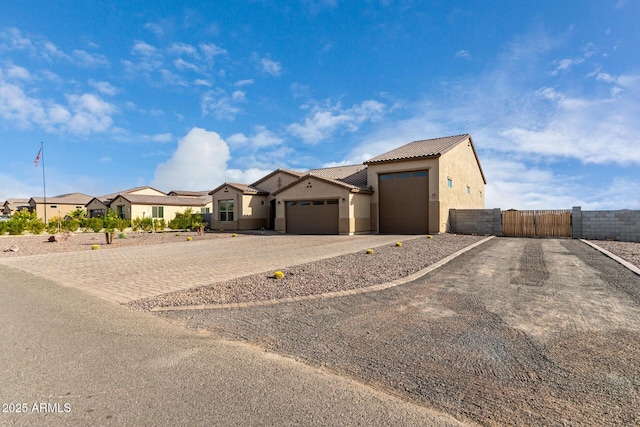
left=0, top=231, right=230, bottom=258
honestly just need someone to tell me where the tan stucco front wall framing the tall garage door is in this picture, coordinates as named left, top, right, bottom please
left=367, top=159, right=446, bottom=233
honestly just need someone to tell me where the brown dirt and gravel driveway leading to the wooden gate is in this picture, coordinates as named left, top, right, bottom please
left=157, top=238, right=640, bottom=426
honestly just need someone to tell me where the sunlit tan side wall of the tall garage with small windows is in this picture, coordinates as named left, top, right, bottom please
left=439, top=143, right=485, bottom=232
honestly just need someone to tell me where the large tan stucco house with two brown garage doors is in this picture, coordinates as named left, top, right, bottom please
left=209, top=134, right=486, bottom=234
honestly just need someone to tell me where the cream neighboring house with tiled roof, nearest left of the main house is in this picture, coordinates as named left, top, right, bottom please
left=109, top=194, right=211, bottom=222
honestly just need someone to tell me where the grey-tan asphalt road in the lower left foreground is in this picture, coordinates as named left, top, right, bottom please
left=0, top=266, right=458, bottom=426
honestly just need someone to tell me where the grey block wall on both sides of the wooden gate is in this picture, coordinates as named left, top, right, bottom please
left=449, top=206, right=640, bottom=242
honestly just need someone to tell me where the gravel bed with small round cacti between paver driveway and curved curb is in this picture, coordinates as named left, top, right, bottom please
left=129, top=234, right=484, bottom=310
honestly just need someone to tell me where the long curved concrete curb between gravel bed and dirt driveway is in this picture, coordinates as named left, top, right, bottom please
left=150, top=236, right=496, bottom=312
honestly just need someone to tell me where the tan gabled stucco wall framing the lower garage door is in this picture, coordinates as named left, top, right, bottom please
left=275, top=177, right=353, bottom=234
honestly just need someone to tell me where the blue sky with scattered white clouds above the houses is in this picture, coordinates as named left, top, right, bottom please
left=0, top=0, right=640, bottom=209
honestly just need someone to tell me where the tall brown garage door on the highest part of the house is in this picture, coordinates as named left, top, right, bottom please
left=378, top=170, right=429, bottom=234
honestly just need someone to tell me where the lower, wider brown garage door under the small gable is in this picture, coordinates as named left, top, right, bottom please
left=285, top=199, right=338, bottom=234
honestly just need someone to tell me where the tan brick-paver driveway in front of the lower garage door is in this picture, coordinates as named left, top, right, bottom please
left=0, top=235, right=418, bottom=303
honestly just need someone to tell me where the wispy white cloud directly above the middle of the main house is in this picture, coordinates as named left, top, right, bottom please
left=287, top=100, right=385, bottom=144
